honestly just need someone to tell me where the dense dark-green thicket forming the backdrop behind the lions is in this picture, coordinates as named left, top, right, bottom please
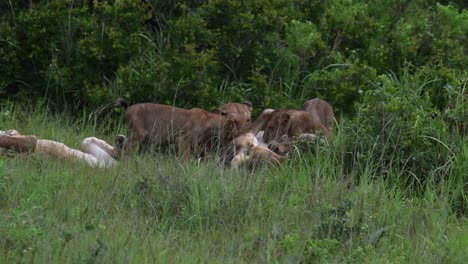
left=0, top=0, right=468, bottom=114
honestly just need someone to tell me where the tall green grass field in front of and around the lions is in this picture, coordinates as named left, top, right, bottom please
left=0, top=105, right=468, bottom=263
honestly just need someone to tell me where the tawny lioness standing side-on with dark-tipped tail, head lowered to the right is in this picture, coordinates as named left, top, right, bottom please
left=120, top=100, right=249, bottom=158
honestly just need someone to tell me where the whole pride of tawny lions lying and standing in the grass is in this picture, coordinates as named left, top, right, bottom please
left=0, top=98, right=334, bottom=168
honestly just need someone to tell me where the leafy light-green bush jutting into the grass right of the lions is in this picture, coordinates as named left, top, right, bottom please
left=351, top=65, right=464, bottom=186
